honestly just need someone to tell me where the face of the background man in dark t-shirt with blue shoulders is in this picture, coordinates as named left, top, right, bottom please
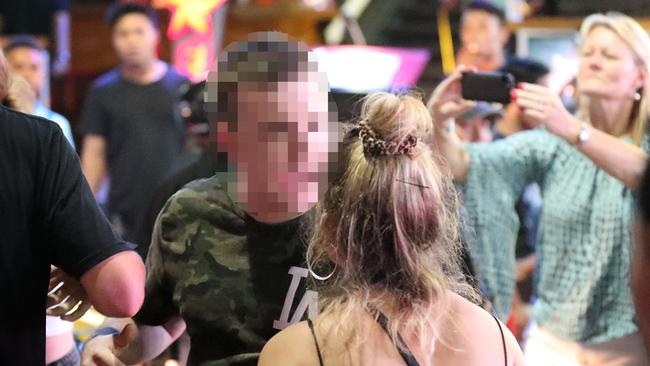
left=113, top=13, right=158, bottom=65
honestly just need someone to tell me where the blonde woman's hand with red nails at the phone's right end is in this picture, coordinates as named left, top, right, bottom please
left=511, top=83, right=580, bottom=144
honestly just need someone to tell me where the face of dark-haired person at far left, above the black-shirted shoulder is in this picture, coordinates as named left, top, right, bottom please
left=6, top=47, right=45, bottom=95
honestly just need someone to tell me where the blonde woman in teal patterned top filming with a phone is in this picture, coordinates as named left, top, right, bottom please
left=430, top=13, right=650, bottom=366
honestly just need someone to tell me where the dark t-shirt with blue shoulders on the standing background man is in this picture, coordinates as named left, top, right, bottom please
left=81, top=67, right=187, bottom=240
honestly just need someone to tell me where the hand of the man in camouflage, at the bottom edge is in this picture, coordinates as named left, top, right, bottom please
left=81, top=324, right=137, bottom=366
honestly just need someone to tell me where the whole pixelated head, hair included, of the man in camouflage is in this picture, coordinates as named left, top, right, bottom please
left=205, top=38, right=342, bottom=223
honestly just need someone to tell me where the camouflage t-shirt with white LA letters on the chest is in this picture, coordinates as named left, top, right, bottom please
left=136, top=176, right=317, bottom=366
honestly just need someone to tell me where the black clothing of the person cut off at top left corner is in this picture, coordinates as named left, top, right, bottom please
left=0, top=0, right=70, bottom=35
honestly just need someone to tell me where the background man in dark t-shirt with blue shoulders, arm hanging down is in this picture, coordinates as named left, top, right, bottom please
left=81, top=4, right=187, bottom=244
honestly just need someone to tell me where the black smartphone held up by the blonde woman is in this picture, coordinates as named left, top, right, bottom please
left=461, top=72, right=515, bottom=104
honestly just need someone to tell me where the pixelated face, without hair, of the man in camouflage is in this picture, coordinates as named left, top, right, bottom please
left=229, top=77, right=337, bottom=222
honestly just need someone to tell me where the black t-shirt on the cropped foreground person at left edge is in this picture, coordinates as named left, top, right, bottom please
left=0, top=107, right=133, bottom=366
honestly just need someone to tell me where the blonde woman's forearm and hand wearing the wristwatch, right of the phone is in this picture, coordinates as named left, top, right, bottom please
left=516, top=83, right=648, bottom=190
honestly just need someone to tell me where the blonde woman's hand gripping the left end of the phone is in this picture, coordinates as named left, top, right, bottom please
left=427, top=65, right=476, bottom=127
